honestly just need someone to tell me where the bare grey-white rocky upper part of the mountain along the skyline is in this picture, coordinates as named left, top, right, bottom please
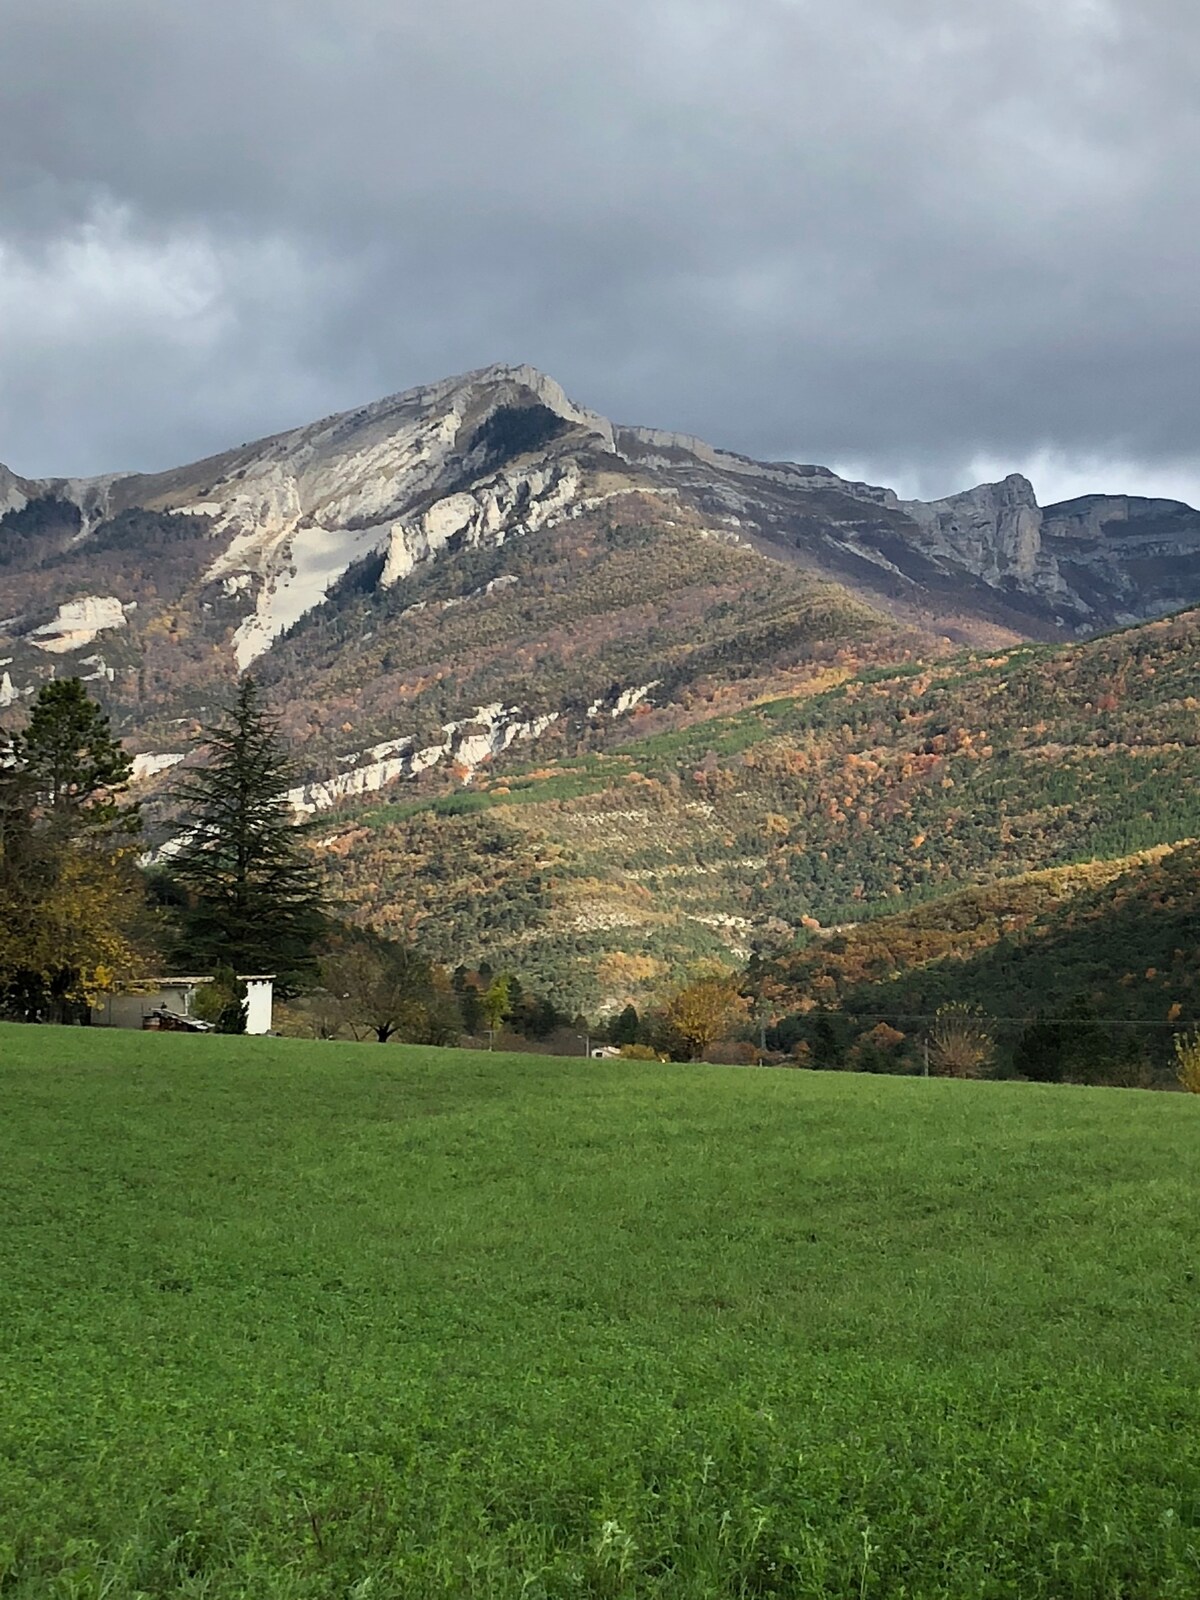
left=0, top=366, right=1200, bottom=667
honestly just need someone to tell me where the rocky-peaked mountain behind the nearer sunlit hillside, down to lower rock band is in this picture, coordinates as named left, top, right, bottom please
left=0, top=366, right=1200, bottom=806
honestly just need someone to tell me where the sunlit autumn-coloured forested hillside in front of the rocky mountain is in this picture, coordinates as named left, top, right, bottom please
left=316, top=613, right=1200, bottom=1006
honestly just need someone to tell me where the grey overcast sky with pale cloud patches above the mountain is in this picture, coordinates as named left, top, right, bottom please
left=0, top=0, right=1200, bottom=502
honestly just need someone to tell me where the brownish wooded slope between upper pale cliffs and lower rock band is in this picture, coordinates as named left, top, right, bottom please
left=259, top=494, right=928, bottom=776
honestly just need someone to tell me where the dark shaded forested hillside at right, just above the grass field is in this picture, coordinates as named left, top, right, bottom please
left=770, top=843, right=1200, bottom=1066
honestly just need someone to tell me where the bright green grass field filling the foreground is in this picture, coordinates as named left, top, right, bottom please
left=0, top=1027, right=1200, bottom=1600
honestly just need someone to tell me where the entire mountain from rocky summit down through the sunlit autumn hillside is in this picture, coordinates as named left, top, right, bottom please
left=0, top=366, right=1200, bottom=1010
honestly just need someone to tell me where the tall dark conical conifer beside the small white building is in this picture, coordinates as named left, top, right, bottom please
left=168, top=678, right=325, bottom=994
